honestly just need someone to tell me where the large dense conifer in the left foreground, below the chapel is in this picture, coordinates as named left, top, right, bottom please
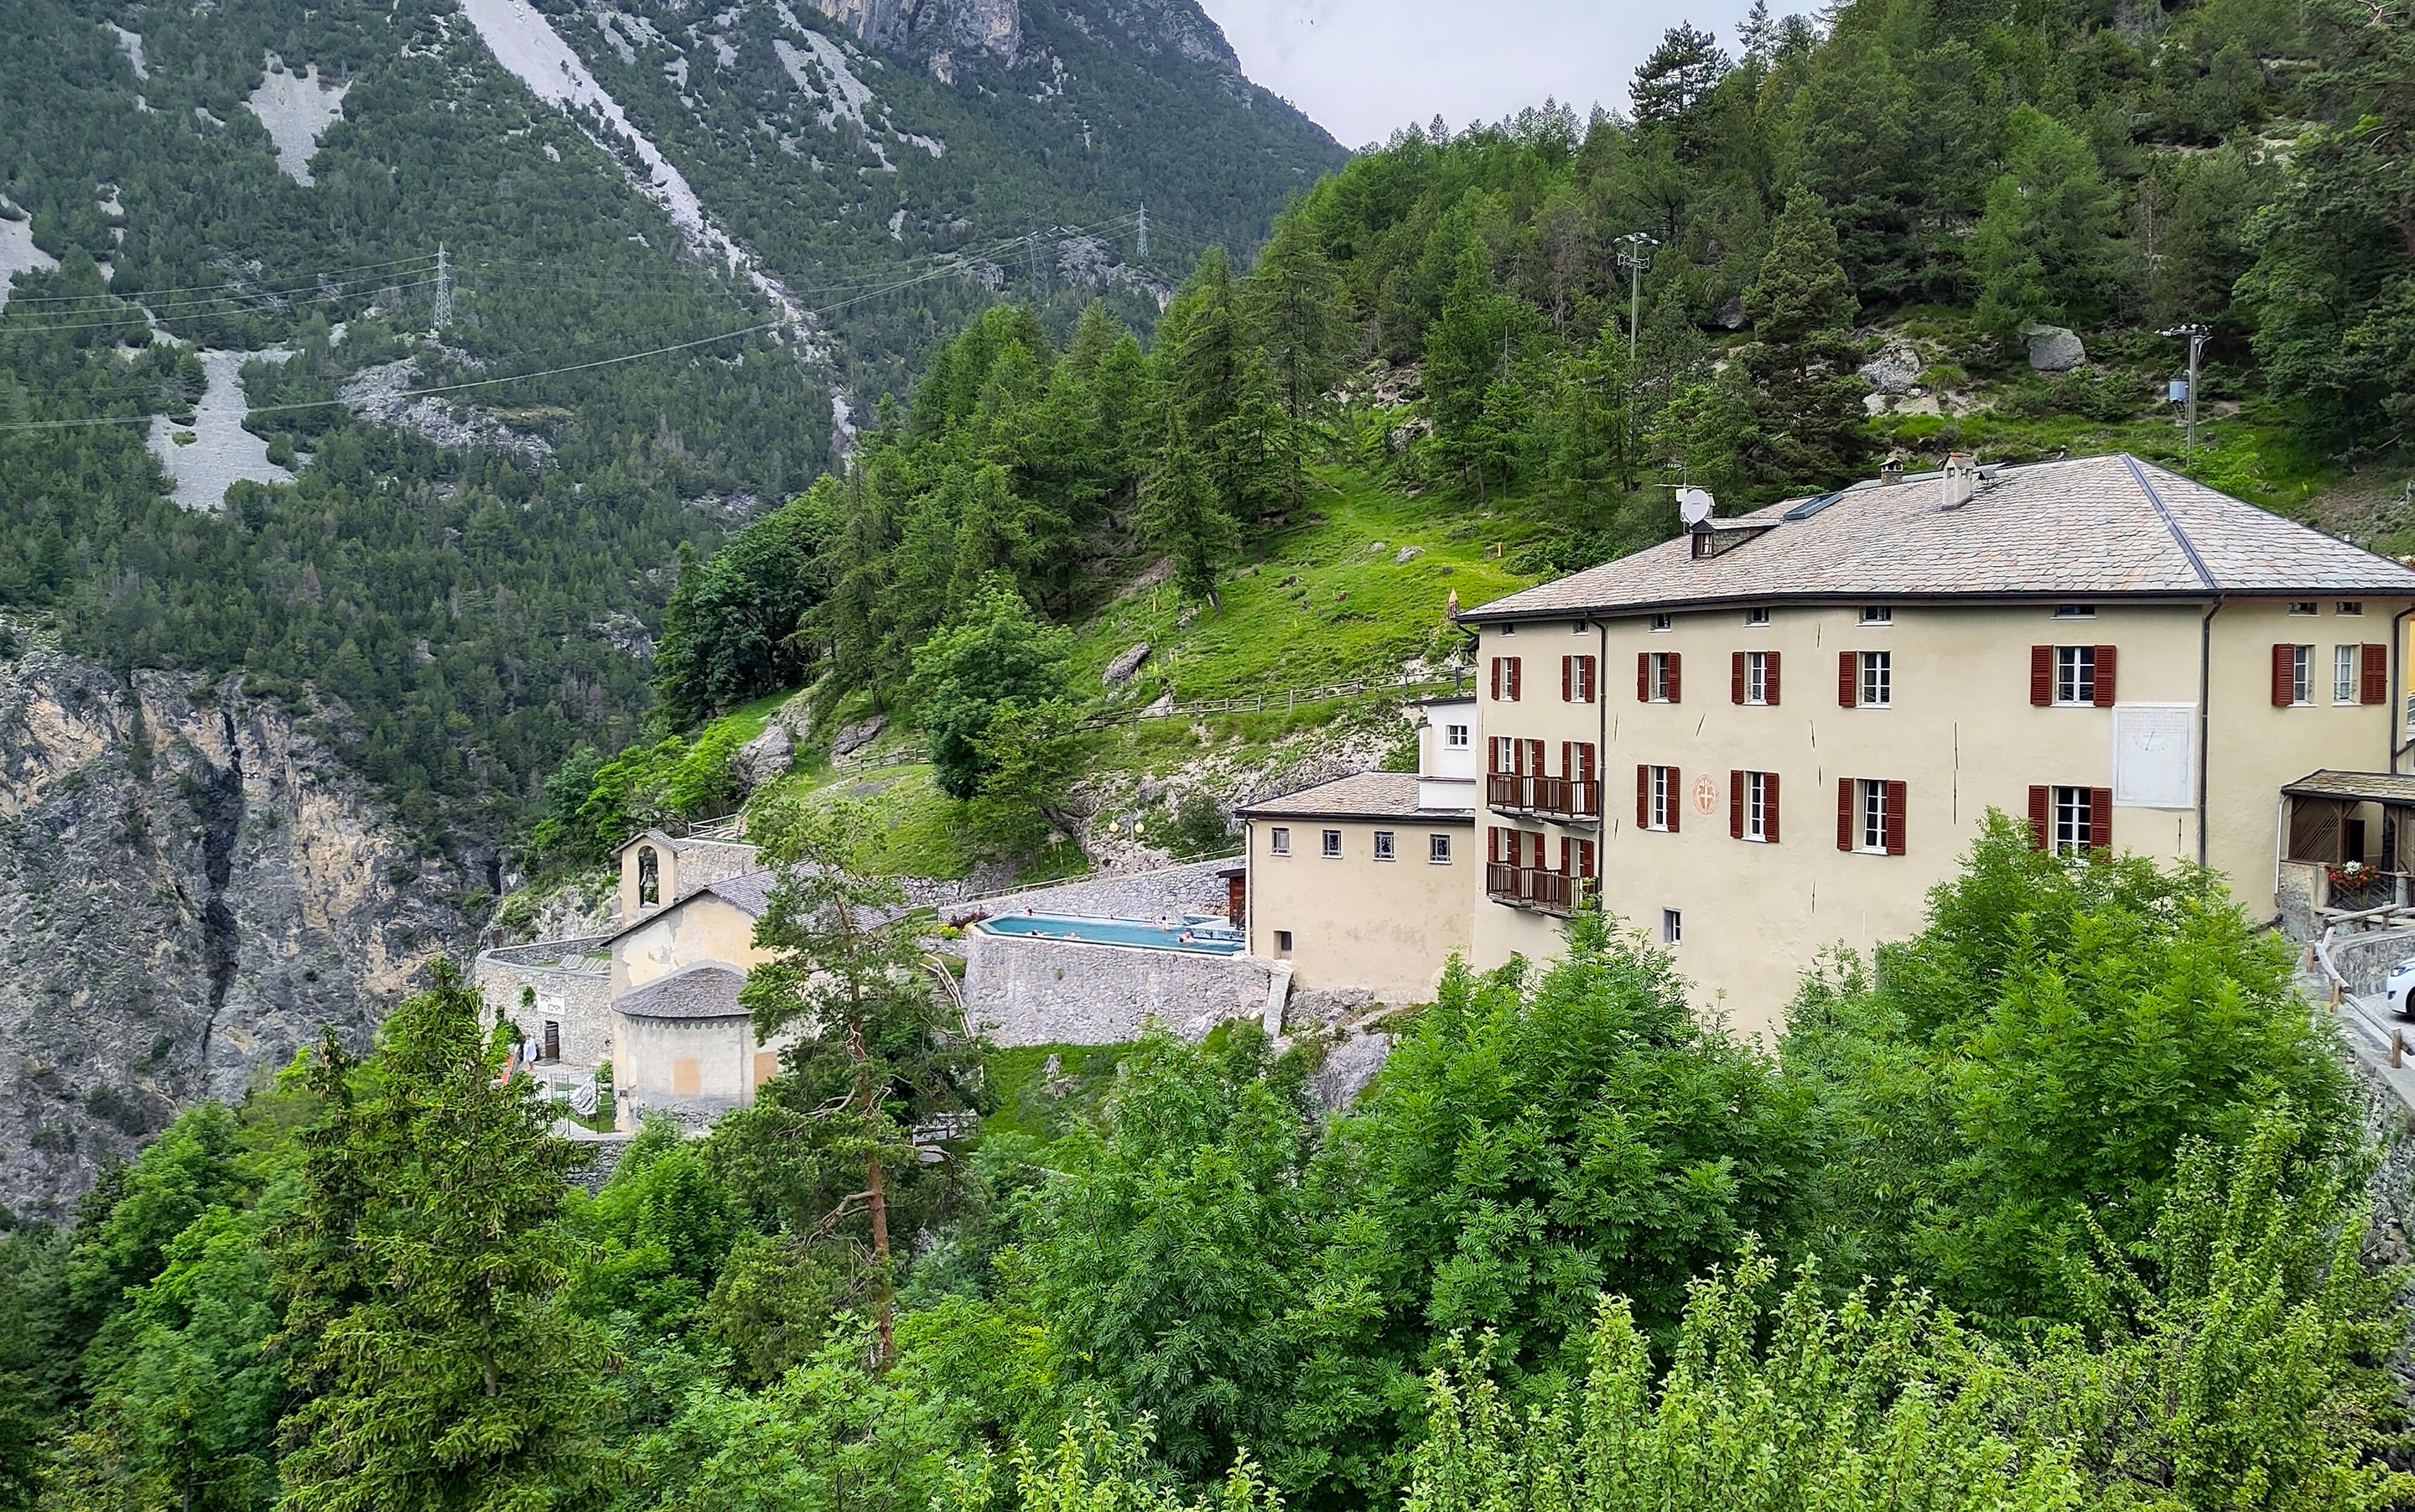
left=275, top=961, right=614, bottom=1512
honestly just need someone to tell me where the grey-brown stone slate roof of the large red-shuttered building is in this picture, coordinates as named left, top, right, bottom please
left=1461, top=454, right=2415, bottom=623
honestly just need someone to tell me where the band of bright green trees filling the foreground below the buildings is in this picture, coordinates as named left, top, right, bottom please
left=0, top=802, right=2415, bottom=1512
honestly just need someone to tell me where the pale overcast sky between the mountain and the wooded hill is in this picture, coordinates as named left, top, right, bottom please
left=1200, top=0, right=1768, bottom=148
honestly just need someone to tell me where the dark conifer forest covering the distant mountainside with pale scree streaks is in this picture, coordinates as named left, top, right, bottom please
left=0, top=0, right=1338, bottom=848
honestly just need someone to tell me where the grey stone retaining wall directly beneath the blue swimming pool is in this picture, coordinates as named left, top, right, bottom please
left=963, top=930, right=1273, bottom=1046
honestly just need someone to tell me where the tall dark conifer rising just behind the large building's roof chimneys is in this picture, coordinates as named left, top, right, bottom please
left=1737, top=189, right=1869, bottom=491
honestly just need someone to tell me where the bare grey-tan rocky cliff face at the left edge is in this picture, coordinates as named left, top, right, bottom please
left=0, top=632, right=466, bottom=1215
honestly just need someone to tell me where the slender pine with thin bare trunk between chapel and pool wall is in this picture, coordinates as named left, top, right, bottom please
left=717, top=795, right=980, bottom=1362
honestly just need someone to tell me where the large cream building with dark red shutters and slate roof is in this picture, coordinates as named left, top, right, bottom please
left=1449, top=456, right=2415, bottom=1031
